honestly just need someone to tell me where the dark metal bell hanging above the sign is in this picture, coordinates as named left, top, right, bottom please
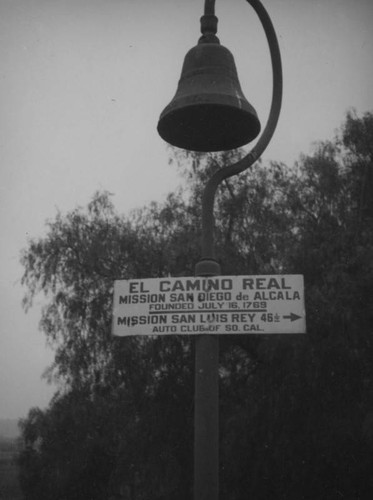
left=157, top=43, right=260, bottom=152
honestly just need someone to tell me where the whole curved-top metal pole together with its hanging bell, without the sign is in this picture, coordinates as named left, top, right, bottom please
left=157, top=0, right=282, bottom=500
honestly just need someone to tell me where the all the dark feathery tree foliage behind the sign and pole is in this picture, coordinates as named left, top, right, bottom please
left=20, top=112, right=373, bottom=500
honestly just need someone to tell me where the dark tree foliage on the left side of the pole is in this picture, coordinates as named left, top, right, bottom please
left=21, top=193, right=198, bottom=500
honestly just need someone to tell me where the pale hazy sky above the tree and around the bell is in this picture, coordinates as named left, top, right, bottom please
left=0, top=0, right=373, bottom=418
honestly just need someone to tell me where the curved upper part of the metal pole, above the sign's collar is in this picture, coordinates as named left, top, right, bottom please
left=202, top=0, right=282, bottom=259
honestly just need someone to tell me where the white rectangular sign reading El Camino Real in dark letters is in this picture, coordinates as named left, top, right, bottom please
left=112, top=274, right=306, bottom=336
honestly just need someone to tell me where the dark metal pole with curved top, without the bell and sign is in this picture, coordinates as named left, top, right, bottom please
left=194, top=0, right=282, bottom=500
